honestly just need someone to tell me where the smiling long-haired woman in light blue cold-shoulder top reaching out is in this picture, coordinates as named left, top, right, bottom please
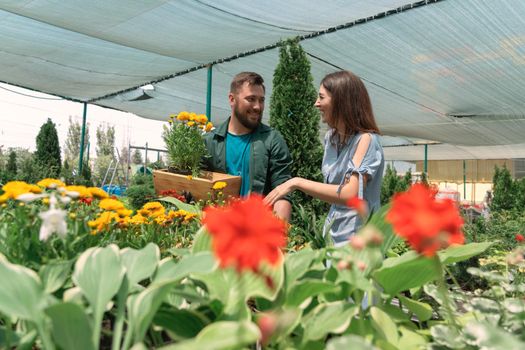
left=265, top=71, right=384, bottom=246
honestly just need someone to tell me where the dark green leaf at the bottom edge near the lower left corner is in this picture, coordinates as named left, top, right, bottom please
left=45, top=303, right=96, bottom=350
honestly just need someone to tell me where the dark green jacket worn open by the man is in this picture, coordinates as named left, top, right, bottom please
left=204, top=118, right=292, bottom=199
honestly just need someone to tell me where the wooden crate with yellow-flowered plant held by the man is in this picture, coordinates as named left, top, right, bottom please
left=153, top=112, right=241, bottom=200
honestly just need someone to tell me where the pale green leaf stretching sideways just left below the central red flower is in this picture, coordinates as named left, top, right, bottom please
left=153, top=252, right=217, bottom=283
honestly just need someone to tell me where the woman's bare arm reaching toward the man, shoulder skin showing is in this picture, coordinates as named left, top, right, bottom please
left=264, top=134, right=371, bottom=205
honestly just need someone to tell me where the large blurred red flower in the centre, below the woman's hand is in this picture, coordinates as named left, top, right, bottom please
left=203, top=195, right=286, bottom=272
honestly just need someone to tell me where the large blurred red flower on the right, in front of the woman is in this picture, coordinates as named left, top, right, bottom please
left=386, top=184, right=465, bottom=257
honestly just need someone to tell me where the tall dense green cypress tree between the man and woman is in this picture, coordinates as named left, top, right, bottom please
left=270, top=39, right=324, bottom=210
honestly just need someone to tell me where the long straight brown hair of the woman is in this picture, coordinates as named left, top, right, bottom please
left=321, top=71, right=380, bottom=135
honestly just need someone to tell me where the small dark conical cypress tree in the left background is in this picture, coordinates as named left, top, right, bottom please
left=35, top=118, right=62, bottom=177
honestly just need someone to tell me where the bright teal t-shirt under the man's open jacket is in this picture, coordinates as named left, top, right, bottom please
left=226, top=133, right=252, bottom=196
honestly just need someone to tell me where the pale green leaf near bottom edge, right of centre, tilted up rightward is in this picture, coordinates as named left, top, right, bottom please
left=302, top=301, right=359, bottom=340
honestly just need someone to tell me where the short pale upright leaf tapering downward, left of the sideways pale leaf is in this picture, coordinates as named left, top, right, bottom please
left=120, top=243, right=160, bottom=286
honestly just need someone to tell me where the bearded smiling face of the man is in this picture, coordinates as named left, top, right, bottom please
left=229, top=82, right=264, bottom=130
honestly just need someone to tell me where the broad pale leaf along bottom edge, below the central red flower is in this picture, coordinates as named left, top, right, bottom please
left=159, top=321, right=260, bottom=350
